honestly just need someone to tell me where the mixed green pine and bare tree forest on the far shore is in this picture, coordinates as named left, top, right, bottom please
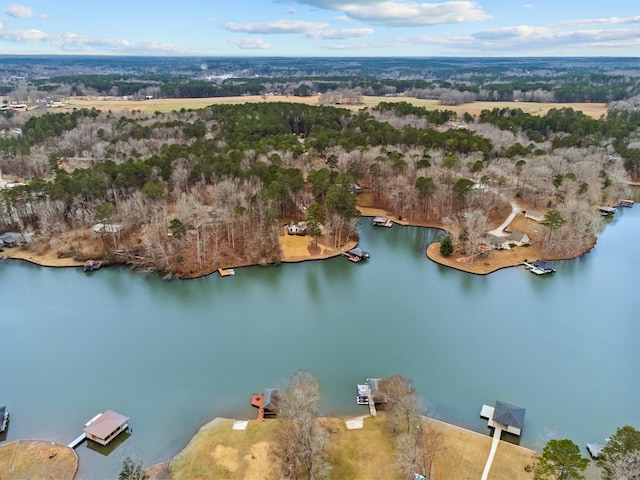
left=0, top=89, right=640, bottom=276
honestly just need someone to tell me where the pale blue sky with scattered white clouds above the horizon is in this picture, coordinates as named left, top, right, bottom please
left=0, top=0, right=640, bottom=56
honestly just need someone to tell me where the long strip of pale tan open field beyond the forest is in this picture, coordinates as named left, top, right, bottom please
left=63, top=95, right=607, bottom=118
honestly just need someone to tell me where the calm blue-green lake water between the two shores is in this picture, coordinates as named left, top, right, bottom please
left=0, top=205, right=640, bottom=478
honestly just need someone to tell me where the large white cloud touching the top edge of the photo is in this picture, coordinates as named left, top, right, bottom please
left=288, top=0, right=491, bottom=27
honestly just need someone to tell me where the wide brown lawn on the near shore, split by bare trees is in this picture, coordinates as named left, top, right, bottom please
left=158, top=412, right=535, bottom=480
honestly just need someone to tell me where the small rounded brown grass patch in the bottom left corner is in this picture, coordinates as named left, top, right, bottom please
left=0, top=440, right=78, bottom=480
